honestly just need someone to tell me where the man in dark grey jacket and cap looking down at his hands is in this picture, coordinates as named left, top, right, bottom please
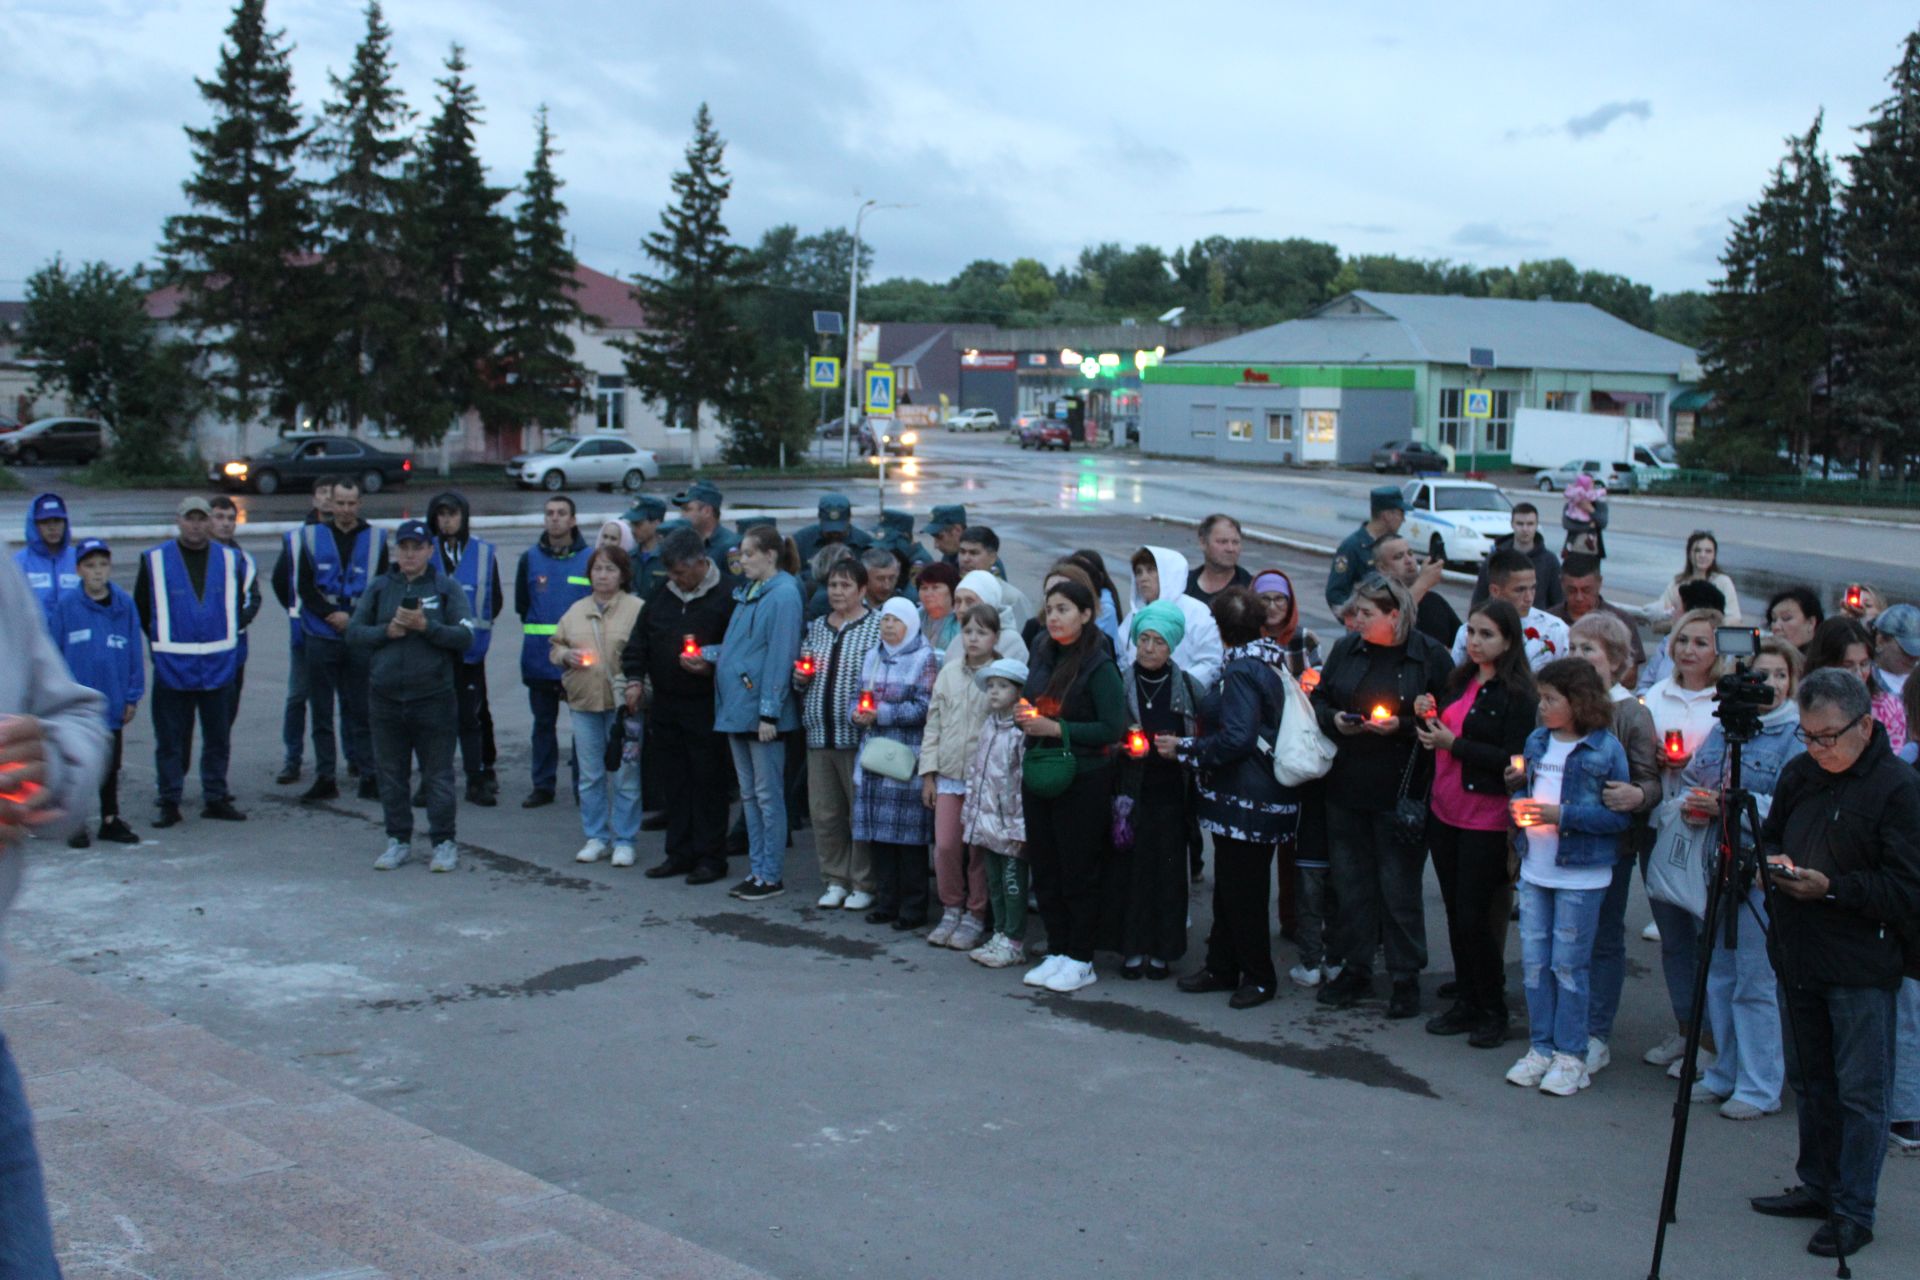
left=348, top=520, right=474, bottom=871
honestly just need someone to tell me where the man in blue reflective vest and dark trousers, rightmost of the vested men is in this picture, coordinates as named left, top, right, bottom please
left=513, top=493, right=593, bottom=808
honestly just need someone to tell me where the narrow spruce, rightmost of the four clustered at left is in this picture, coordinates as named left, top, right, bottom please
left=482, top=107, right=586, bottom=441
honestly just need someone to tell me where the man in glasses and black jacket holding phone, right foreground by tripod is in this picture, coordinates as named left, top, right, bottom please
left=1741, top=670, right=1920, bottom=1257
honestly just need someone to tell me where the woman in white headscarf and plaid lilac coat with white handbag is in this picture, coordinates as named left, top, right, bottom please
left=849, top=597, right=939, bottom=931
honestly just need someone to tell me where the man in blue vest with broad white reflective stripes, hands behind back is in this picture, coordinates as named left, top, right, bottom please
left=132, top=497, right=259, bottom=827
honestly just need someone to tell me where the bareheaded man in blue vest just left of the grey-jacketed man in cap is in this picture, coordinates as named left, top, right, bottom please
left=300, top=476, right=388, bottom=802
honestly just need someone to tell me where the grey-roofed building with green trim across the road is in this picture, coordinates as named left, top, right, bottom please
left=1140, top=292, right=1699, bottom=468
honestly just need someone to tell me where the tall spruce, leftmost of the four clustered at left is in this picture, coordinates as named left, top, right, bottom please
left=159, top=0, right=317, bottom=420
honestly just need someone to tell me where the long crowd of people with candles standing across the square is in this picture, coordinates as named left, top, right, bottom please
left=17, top=478, right=1920, bottom=1253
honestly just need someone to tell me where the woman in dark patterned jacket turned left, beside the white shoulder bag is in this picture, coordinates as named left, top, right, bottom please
left=1154, top=587, right=1300, bottom=1009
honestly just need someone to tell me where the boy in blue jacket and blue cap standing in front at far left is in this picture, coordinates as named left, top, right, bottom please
left=54, top=537, right=146, bottom=848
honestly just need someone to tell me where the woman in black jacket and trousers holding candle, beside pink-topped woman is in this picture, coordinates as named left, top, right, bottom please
left=1313, top=574, right=1453, bottom=1017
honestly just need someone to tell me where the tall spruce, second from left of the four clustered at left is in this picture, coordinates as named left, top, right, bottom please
left=309, top=0, right=434, bottom=434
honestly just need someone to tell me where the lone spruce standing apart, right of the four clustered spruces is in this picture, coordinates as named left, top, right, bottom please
left=622, top=102, right=753, bottom=468
